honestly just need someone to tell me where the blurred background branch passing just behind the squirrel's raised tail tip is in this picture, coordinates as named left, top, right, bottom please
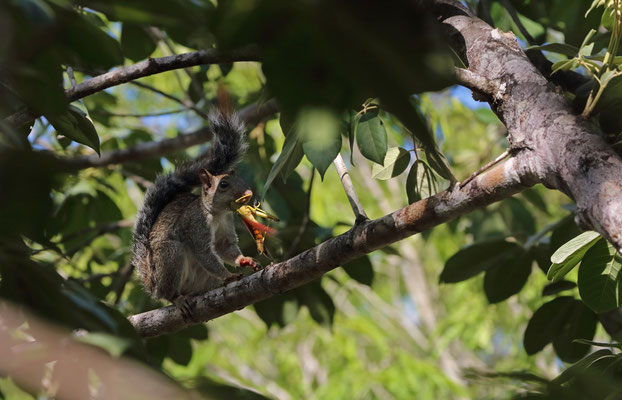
left=65, top=100, right=278, bottom=169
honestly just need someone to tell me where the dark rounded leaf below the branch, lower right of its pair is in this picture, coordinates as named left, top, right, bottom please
left=484, top=250, right=533, bottom=304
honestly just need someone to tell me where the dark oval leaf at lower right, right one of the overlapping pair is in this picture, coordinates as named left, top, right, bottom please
left=553, top=300, right=598, bottom=363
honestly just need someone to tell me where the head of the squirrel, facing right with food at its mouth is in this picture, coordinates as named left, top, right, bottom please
left=199, top=169, right=253, bottom=214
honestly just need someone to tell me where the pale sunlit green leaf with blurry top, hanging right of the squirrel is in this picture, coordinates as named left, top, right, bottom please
left=298, top=108, right=341, bottom=179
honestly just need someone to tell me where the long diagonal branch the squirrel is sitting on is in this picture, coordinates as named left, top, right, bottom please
left=129, top=158, right=535, bottom=337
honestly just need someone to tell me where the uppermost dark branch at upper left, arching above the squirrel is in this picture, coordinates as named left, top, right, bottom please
left=5, top=47, right=259, bottom=126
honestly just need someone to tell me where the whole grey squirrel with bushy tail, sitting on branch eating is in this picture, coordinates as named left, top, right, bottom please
left=132, top=108, right=259, bottom=319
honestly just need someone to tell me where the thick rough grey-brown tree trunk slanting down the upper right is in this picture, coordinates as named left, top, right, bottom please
left=432, top=0, right=622, bottom=251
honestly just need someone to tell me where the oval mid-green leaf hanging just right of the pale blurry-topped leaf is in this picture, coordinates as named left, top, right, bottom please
left=354, top=109, right=388, bottom=164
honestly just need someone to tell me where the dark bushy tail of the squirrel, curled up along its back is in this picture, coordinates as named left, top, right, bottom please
left=132, top=109, right=247, bottom=268
